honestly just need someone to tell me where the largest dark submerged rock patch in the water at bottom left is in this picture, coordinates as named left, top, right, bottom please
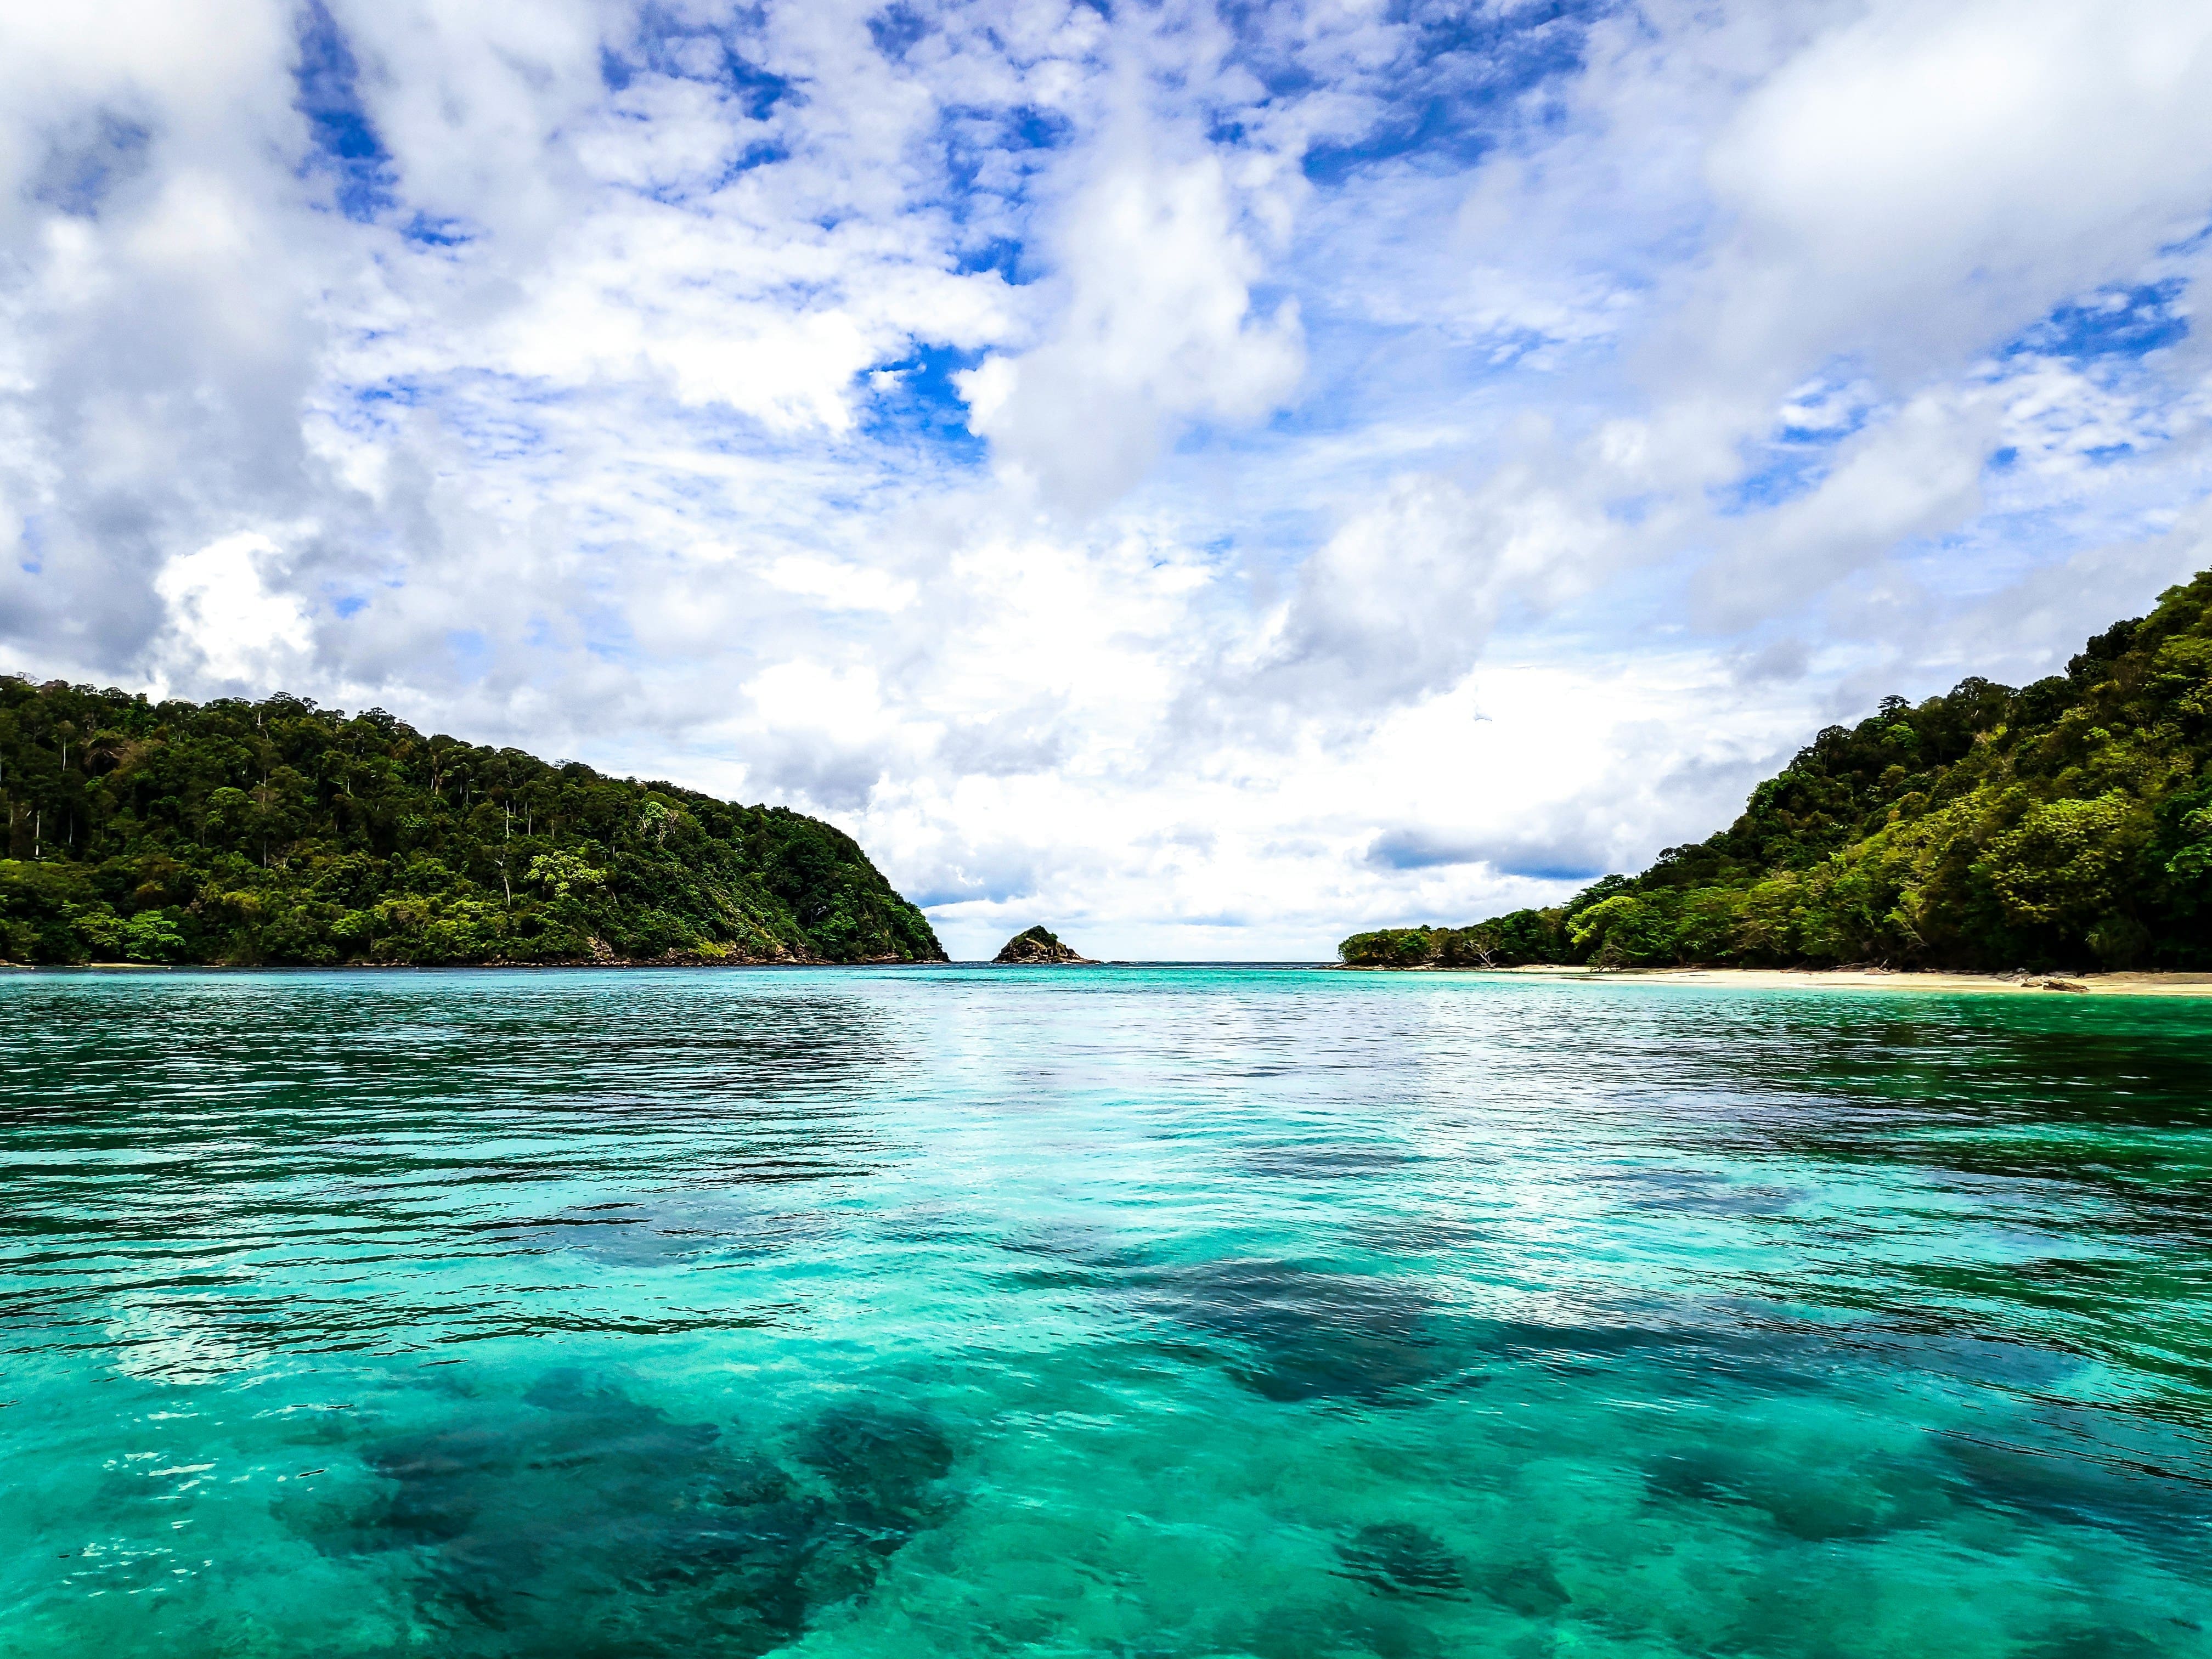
left=298, top=1372, right=953, bottom=1659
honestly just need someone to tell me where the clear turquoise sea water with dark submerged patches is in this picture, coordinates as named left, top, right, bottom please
left=0, top=969, right=2212, bottom=1659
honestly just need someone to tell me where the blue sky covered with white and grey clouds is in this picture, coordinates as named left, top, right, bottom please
left=0, top=0, right=2212, bottom=960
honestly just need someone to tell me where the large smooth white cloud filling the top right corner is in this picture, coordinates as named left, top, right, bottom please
left=1708, top=0, right=2212, bottom=363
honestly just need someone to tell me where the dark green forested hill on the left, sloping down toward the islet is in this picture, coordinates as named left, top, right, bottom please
left=0, top=677, right=945, bottom=964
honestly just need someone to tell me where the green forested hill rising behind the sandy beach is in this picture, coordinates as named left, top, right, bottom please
left=1338, top=571, right=2212, bottom=969
